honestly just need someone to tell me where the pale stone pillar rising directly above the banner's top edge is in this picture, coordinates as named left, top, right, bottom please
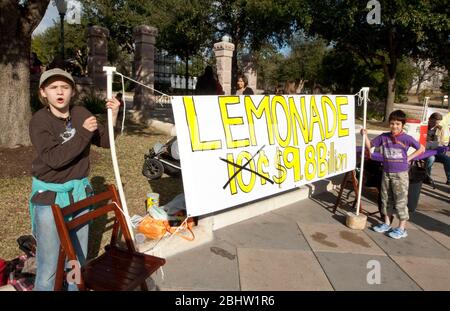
left=214, top=41, right=234, bottom=95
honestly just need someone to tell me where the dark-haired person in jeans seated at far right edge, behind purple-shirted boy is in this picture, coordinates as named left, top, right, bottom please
left=424, top=112, right=450, bottom=185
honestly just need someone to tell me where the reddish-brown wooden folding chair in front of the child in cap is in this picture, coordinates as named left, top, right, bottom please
left=52, top=185, right=165, bottom=291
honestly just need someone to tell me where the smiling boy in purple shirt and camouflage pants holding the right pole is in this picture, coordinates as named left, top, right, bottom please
left=361, top=110, right=425, bottom=239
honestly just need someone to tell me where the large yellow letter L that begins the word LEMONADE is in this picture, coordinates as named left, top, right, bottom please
left=183, top=96, right=222, bottom=151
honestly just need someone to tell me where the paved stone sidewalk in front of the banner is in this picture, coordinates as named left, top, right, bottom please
left=149, top=158, right=450, bottom=291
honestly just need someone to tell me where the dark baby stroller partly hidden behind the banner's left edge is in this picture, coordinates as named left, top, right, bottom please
left=142, top=137, right=181, bottom=181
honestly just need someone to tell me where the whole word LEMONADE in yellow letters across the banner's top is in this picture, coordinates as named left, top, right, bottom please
left=183, top=95, right=349, bottom=151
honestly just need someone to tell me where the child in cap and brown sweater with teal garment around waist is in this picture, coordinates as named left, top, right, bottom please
left=29, top=68, right=120, bottom=290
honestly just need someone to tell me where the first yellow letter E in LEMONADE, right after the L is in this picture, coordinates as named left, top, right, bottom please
left=219, top=96, right=250, bottom=149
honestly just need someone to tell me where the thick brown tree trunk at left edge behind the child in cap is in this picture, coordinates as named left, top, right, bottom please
left=0, top=0, right=50, bottom=147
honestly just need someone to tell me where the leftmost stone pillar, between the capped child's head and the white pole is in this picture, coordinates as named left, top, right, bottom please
left=87, top=26, right=109, bottom=90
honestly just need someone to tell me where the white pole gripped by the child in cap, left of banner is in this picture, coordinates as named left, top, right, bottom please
left=103, top=66, right=134, bottom=243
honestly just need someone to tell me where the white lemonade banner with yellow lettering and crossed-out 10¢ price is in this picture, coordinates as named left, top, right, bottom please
left=172, top=95, right=356, bottom=216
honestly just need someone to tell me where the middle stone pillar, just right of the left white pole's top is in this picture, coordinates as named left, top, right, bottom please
left=133, top=25, right=158, bottom=111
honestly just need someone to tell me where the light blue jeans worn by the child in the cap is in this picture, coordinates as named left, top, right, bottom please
left=33, top=205, right=89, bottom=291
